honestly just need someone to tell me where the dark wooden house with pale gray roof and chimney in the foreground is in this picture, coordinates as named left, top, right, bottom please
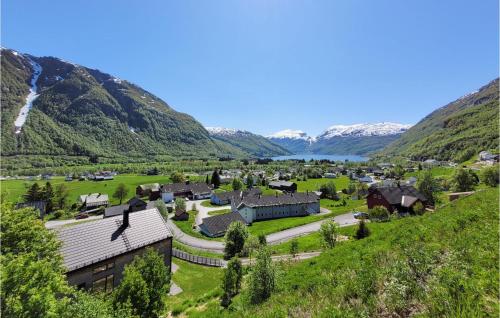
left=56, top=208, right=172, bottom=292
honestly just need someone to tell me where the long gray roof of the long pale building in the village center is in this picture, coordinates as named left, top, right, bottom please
left=237, top=192, right=319, bottom=208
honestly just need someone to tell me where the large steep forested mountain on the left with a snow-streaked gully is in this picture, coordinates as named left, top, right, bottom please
left=1, top=49, right=249, bottom=158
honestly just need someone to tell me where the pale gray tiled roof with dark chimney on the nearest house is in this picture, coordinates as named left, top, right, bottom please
left=56, top=208, right=172, bottom=271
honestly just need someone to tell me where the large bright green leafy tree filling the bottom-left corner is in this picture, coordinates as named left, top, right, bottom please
left=0, top=205, right=71, bottom=317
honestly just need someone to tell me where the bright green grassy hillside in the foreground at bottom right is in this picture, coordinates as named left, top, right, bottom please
left=201, top=189, right=499, bottom=317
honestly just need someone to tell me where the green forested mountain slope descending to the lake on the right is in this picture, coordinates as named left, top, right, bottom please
left=381, top=79, right=499, bottom=162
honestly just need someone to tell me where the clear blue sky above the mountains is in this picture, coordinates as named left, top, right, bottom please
left=1, top=0, right=499, bottom=135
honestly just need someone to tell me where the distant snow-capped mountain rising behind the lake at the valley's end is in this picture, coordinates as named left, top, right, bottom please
left=267, top=122, right=411, bottom=155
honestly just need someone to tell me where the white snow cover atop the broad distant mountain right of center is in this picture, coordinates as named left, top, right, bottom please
left=318, top=122, right=412, bottom=139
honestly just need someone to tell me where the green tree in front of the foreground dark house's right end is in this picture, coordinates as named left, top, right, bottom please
left=114, top=248, right=170, bottom=317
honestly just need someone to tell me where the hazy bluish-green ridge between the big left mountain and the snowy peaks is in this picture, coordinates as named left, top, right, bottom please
left=207, top=127, right=291, bottom=157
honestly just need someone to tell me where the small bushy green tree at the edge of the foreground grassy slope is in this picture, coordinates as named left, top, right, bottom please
left=249, top=246, right=277, bottom=304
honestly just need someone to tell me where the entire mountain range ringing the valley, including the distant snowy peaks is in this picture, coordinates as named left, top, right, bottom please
left=0, top=48, right=498, bottom=161
